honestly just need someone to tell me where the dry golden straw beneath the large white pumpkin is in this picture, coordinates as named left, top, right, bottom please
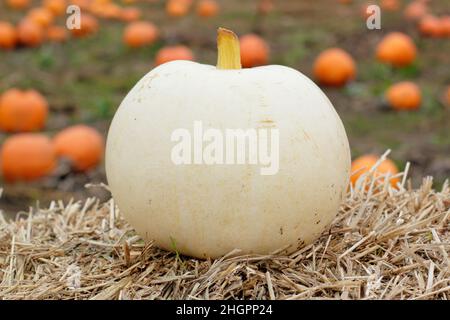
left=0, top=159, right=450, bottom=299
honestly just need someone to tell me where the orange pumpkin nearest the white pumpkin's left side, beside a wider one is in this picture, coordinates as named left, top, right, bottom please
left=53, top=125, right=104, bottom=171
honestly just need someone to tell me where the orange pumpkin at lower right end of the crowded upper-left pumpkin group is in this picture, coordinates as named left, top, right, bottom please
left=123, top=21, right=159, bottom=48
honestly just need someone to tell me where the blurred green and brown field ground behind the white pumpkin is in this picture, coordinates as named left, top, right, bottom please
left=0, top=0, right=450, bottom=216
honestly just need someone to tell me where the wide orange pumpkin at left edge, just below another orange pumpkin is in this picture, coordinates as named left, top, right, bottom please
left=0, top=133, right=57, bottom=182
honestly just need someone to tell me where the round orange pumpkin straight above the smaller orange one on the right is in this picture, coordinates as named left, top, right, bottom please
left=376, top=32, right=417, bottom=67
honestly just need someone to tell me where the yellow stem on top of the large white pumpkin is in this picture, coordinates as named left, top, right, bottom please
left=217, top=28, right=242, bottom=70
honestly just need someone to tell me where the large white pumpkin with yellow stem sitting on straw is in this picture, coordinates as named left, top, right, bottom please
left=106, top=29, right=350, bottom=258
